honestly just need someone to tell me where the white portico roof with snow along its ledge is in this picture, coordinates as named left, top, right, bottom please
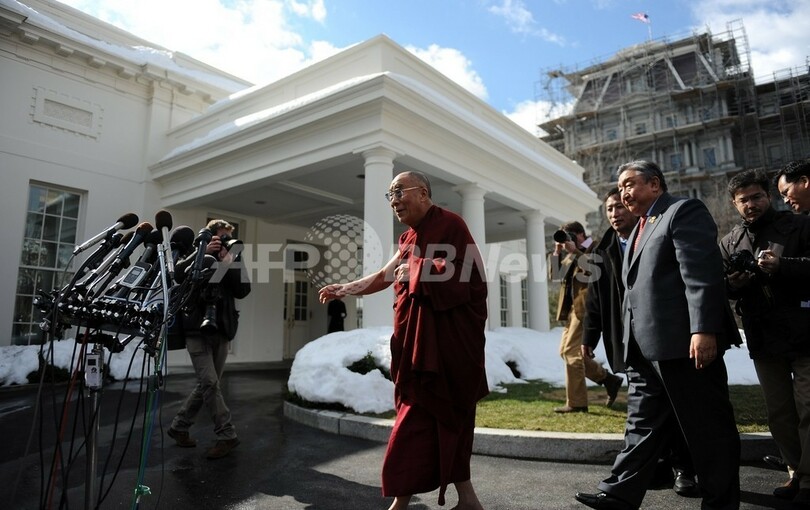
left=150, top=35, right=599, bottom=242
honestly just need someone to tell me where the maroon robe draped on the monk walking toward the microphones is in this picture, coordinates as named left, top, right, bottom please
left=382, top=205, right=489, bottom=505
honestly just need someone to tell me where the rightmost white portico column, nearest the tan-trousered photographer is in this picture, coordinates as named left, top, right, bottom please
left=523, top=211, right=551, bottom=331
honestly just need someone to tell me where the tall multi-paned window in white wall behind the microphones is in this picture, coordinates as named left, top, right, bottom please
left=11, top=184, right=80, bottom=345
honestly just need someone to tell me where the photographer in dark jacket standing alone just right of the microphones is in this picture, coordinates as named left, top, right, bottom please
left=168, top=220, right=250, bottom=459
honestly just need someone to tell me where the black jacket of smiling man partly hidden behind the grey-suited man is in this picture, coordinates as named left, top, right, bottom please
left=582, top=228, right=626, bottom=372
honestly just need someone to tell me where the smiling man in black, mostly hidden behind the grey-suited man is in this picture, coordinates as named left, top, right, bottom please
left=582, top=187, right=700, bottom=497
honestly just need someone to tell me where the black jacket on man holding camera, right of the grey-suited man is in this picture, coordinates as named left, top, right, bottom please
left=720, top=209, right=810, bottom=358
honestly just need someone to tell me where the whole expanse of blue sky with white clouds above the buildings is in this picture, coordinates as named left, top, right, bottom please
left=53, top=0, right=810, bottom=132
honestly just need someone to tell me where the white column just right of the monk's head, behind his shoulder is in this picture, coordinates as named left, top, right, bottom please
left=453, top=183, right=501, bottom=329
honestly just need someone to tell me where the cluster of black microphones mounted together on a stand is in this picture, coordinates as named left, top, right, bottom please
left=36, top=210, right=211, bottom=352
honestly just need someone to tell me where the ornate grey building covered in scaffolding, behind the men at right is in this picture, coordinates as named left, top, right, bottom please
left=537, top=21, right=810, bottom=233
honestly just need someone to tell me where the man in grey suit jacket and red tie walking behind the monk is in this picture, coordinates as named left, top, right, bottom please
left=575, top=161, right=741, bottom=510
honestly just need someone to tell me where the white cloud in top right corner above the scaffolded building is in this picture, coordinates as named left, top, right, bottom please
left=693, top=0, right=810, bottom=81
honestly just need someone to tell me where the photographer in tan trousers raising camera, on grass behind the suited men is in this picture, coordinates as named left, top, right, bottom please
left=548, top=221, right=622, bottom=413
